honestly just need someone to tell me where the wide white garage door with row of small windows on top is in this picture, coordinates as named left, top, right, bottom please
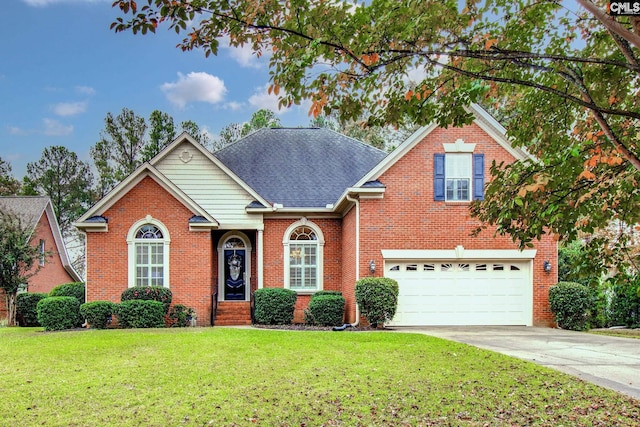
left=385, top=260, right=533, bottom=326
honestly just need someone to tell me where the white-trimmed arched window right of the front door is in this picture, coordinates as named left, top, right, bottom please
left=282, top=218, right=324, bottom=293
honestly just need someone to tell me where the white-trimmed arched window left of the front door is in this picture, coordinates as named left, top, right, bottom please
left=127, top=215, right=171, bottom=288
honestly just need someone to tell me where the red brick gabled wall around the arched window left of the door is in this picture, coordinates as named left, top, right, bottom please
left=87, top=177, right=217, bottom=325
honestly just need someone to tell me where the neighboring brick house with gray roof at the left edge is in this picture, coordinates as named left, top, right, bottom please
left=0, top=196, right=82, bottom=319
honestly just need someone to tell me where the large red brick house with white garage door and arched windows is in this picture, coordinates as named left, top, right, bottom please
left=76, top=106, right=557, bottom=325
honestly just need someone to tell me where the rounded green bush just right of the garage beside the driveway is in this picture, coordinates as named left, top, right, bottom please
left=549, top=282, right=593, bottom=331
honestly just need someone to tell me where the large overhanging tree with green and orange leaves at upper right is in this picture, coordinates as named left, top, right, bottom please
left=112, top=0, right=640, bottom=276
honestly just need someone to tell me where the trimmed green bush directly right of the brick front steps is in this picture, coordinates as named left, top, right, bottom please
left=254, top=288, right=298, bottom=325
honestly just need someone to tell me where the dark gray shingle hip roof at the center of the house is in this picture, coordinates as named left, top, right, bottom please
left=214, top=128, right=387, bottom=208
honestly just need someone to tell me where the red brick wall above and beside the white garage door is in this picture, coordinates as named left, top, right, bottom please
left=359, top=124, right=557, bottom=325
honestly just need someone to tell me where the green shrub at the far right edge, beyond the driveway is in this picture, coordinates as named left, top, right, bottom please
left=609, top=276, right=640, bottom=327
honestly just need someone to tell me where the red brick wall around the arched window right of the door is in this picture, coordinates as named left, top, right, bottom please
left=263, top=218, right=342, bottom=323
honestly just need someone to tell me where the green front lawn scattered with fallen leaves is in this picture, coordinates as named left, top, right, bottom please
left=0, top=328, right=640, bottom=427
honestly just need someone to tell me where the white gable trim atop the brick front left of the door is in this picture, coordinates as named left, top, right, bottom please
left=75, top=163, right=220, bottom=229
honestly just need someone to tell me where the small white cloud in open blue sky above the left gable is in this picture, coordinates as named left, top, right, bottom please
left=160, top=72, right=227, bottom=108
